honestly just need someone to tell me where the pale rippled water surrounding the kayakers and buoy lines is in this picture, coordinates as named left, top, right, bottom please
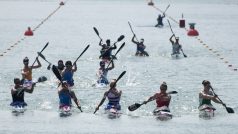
left=0, top=0, right=238, bottom=134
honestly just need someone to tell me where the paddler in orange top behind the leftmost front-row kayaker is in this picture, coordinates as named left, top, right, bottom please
left=21, top=57, right=41, bottom=87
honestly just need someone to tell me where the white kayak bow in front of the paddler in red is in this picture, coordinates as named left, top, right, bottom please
left=153, top=106, right=173, bottom=121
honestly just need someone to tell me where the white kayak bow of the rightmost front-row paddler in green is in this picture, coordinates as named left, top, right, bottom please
left=198, top=104, right=216, bottom=118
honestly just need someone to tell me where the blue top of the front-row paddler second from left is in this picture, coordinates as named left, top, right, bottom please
left=59, top=90, right=72, bottom=108
